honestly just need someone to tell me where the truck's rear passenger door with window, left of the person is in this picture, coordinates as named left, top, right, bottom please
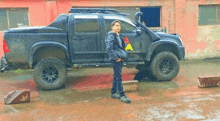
left=69, top=14, right=103, bottom=63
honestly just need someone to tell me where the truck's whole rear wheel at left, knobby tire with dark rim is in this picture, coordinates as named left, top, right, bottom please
left=33, top=58, right=67, bottom=90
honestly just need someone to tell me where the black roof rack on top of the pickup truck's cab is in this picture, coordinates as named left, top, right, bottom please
left=69, top=7, right=129, bottom=16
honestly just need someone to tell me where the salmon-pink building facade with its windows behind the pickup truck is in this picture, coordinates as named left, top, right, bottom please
left=0, top=0, right=220, bottom=59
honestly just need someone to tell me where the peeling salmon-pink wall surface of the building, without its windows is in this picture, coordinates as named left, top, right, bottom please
left=0, top=0, right=220, bottom=59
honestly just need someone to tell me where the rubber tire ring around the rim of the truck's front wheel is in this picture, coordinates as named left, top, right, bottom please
left=150, top=51, right=180, bottom=81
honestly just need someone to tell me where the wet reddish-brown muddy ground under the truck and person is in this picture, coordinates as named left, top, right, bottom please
left=0, top=58, right=220, bottom=121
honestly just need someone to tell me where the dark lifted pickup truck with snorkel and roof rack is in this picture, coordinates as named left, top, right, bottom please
left=1, top=8, right=185, bottom=90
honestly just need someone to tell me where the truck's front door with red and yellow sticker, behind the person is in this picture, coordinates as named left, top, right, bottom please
left=104, top=16, right=145, bottom=62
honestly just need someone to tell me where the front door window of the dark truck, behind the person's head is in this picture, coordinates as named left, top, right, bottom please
left=105, top=19, right=136, bottom=33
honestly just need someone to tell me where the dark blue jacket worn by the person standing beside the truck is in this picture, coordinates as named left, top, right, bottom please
left=105, top=31, right=127, bottom=60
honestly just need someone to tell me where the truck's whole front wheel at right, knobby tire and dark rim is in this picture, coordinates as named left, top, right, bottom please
left=150, top=51, right=180, bottom=81
